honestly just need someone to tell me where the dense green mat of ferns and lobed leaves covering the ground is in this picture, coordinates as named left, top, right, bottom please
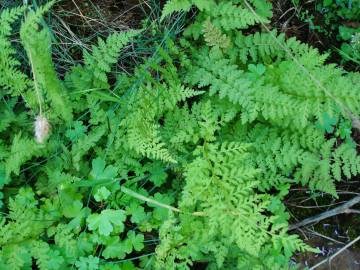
left=0, top=0, right=360, bottom=270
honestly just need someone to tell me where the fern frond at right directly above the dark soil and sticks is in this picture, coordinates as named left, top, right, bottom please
left=228, top=124, right=359, bottom=196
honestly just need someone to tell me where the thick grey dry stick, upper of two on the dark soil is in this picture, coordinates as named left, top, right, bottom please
left=289, top=195, right=360, bottom=231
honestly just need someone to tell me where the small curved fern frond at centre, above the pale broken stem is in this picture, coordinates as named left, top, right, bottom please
left=120, top=44, right=202, bottom=163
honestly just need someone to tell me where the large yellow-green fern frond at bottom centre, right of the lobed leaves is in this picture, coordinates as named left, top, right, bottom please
left=157, top=142, right=314, bottom=269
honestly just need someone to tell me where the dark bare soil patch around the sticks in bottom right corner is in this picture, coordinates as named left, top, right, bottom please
left=286, top=179, right=360, bottom=270
